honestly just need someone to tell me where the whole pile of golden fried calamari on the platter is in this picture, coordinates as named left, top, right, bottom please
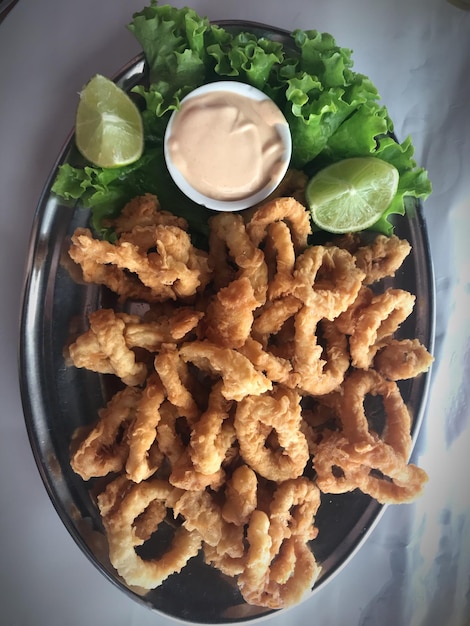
left=67, top=190, right=432, bottom=609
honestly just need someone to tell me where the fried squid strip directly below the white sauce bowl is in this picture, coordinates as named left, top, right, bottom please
left=210, top=213, right=268, bottom=304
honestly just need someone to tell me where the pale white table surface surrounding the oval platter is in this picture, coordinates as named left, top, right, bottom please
left=0, top=0, right=470, bottom=626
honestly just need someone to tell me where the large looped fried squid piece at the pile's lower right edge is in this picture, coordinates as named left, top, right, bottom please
left=313, top=370, right=427, bottom=503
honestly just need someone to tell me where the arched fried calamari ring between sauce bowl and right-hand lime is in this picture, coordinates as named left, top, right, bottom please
left=247, top=198, right=312, bottom=253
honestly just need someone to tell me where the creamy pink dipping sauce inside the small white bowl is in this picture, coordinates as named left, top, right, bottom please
left=168, top=91, right=285, bottom=201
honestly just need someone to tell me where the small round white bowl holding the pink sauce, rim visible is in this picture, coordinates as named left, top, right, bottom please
left=164, top=81, right=292, bottom=211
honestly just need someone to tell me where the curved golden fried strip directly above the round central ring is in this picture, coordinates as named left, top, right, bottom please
left=179, top=341, right=272, bottom=401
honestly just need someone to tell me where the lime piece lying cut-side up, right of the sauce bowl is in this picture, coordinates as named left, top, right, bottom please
left=305, top=157, right=399, bottom=233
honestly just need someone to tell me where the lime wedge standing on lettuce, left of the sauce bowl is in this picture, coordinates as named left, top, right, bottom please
left=75, top=74, right=144, bottom=167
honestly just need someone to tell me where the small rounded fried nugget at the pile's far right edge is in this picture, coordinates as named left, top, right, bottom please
left=374, top=339, right=434, bottom=380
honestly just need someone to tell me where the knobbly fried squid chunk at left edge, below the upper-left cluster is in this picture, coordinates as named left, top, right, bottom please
left=68, top=309, right=147, bottom=386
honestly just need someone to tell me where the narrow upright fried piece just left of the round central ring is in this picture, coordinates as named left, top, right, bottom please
left=189, top=382, right=236, bottom=474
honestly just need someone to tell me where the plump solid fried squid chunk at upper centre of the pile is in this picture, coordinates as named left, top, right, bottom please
left=202, top=276, right=259, bottom=348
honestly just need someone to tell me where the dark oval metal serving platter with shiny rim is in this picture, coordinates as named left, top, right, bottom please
left=20, top=21, right=434, bottom=624
